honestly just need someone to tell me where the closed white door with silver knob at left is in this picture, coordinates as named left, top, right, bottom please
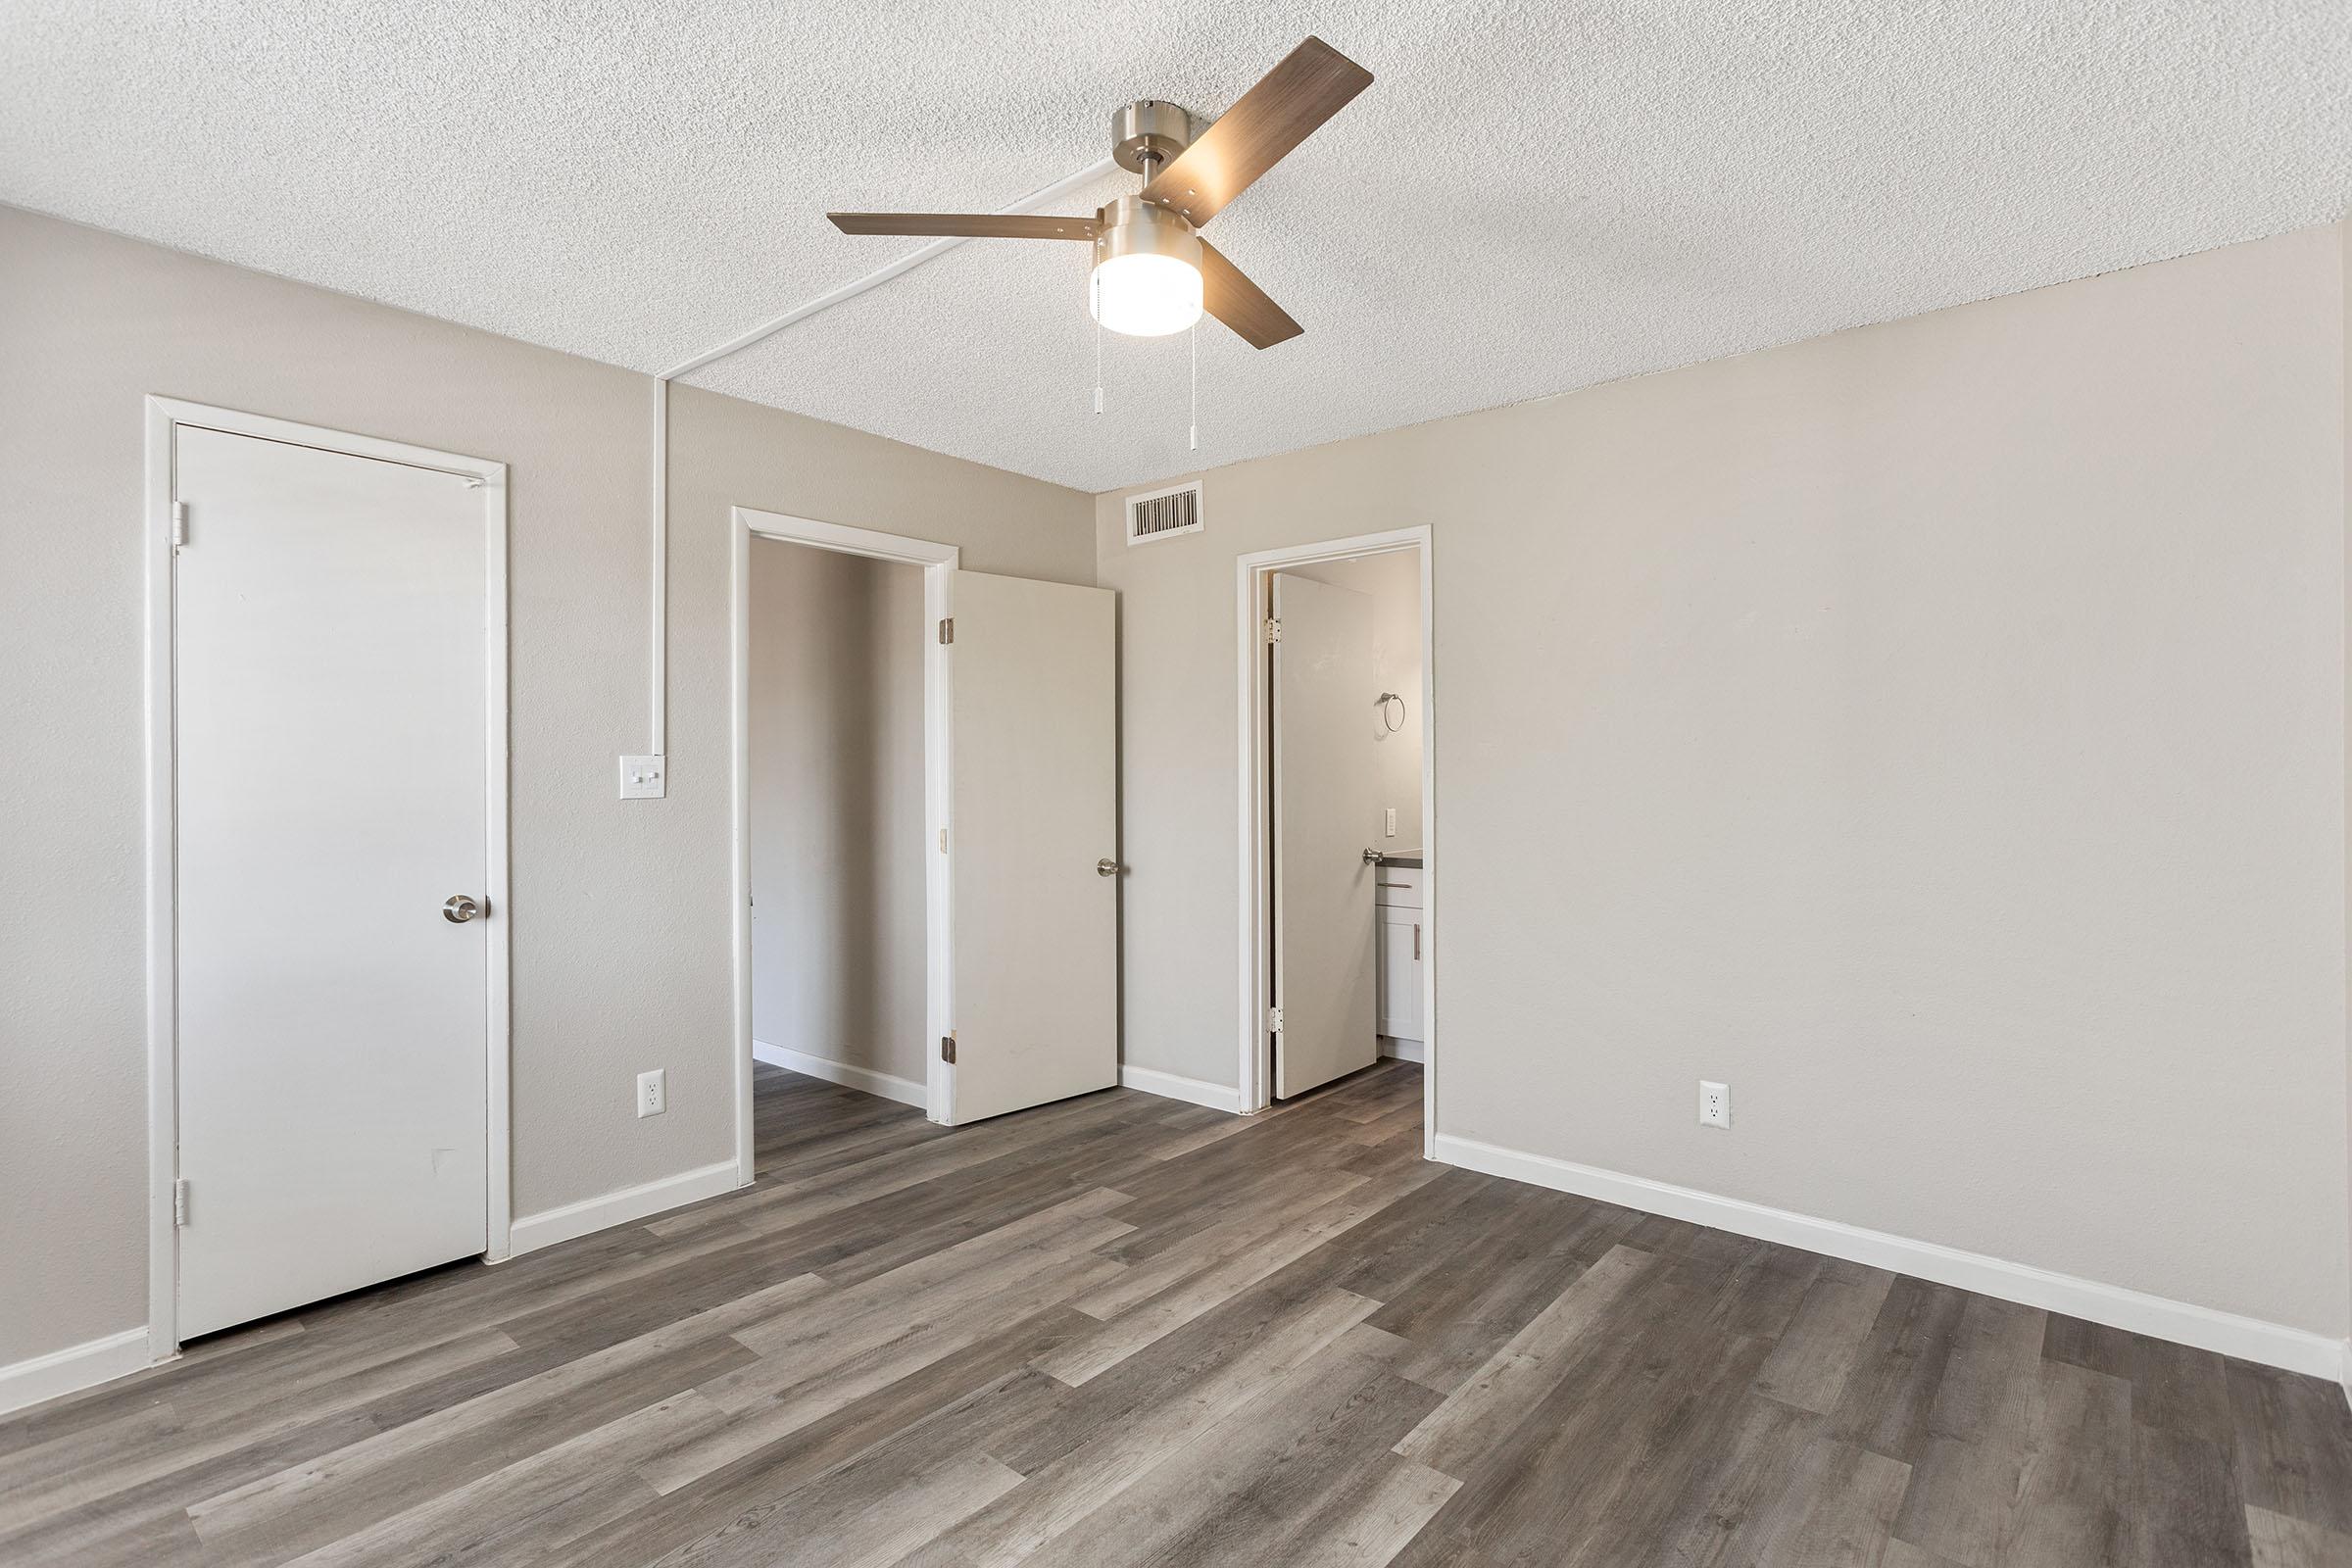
left=172, top=425, right=491, bottom=1338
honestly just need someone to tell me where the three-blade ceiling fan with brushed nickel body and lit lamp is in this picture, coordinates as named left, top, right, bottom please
left=825, top=37, right=1371, bottom=348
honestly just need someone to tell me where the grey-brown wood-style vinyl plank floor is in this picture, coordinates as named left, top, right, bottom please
left=0, top=1062, right=2352, bottom=1568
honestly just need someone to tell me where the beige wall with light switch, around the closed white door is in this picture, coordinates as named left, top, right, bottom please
left=0, top=209, right=1094, bottom=1366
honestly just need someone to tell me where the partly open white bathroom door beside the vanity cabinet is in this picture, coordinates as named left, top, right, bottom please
left=1272, top=571, right=1381, bottom=1098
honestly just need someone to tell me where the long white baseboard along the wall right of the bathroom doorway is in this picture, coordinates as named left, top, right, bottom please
left=1435, top=1133, right=2352, bottom=1394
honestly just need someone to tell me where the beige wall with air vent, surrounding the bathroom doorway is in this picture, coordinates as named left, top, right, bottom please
left=1096, top=228, right=2347, bottom=1336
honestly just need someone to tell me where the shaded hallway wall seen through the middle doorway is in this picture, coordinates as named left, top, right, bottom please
left=751, top=538, right=929, bottom=1091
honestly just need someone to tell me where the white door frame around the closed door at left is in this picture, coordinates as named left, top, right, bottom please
left=141, top=395, right=513, bottom=1361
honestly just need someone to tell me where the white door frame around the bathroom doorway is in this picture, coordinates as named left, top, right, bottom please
left=1235, top=524, right=1442, bottom=1159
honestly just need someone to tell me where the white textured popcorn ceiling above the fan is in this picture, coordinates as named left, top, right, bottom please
left=0, top=0, right=2352, bottom=489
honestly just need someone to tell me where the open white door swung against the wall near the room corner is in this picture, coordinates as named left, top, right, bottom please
left=941, top=571, right=1114, bottom=1126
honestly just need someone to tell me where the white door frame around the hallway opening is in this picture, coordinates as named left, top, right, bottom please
left=729, top=506, right=962, bottom=1185
